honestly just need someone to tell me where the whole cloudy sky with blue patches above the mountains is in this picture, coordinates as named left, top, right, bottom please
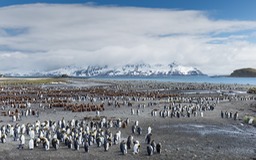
left=0, top=0, right=256, bottom=75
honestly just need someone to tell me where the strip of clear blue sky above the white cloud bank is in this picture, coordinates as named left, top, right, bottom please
left=0, top=0, right=256, bottom=20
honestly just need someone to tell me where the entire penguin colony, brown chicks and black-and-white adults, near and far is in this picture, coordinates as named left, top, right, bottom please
left=0, top=79, right=256, bottom=156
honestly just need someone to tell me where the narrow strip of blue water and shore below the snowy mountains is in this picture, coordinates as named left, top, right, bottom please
left=0, top=76, right=256, bottom=86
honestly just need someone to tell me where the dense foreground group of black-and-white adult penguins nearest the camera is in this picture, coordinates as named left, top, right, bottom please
left=0, top=117, right=162, bottom=155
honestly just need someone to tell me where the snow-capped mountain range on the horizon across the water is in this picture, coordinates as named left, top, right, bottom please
left=5, top=63, right=205, bottom=77
